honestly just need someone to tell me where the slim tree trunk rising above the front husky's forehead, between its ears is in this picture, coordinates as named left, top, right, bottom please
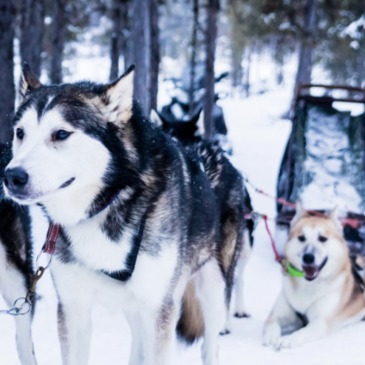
left=50, top=0, right=67, bottom=84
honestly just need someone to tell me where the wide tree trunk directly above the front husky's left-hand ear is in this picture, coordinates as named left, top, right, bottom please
left=20, top=0, right=44, bottom=77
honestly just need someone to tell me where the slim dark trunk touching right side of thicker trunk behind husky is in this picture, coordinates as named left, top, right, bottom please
left=150, top=0, right=160, bottom=110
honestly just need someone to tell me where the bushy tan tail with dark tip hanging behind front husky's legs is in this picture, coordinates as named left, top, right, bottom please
left=176, top=281, right=204, bottom=344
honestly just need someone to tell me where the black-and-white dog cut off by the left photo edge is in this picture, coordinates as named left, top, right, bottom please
left=0, top=147, right=36, bottom=365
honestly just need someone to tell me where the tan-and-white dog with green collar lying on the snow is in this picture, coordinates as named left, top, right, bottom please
left=263, top=208, right=365, bottom=349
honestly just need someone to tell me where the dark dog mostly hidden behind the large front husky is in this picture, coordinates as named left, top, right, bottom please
left=151, top=110, right=254, bottom=322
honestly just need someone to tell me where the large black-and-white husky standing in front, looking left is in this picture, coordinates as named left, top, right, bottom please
left=4, top=66, right=246, bottom=365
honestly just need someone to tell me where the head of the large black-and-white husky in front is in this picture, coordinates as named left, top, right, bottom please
left=4, top=65, right=136, bottom=224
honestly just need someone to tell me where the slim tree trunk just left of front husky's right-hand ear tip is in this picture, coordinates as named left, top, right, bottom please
left=109, top=0, right=122, bottom=81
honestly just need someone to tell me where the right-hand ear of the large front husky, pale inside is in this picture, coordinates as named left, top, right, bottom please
left=102, top=65, right=134, bottom=125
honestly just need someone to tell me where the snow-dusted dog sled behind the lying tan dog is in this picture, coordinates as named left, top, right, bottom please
left=276, top=84, right=365, bottom=258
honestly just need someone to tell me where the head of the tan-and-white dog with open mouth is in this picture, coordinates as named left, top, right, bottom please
left=285, top=207, right=349, bottom=281
